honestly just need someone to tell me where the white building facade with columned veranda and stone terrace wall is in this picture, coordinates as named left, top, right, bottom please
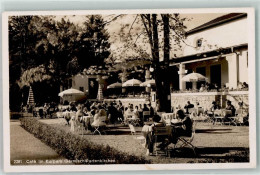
left=170, top=13, right=249, bottom=108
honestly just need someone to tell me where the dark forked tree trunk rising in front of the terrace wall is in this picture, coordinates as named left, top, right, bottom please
left=141, top=14, right=171, bottom=112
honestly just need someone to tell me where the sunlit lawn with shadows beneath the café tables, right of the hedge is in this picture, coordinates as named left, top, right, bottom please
left=41, top=119, right=249, bottom=163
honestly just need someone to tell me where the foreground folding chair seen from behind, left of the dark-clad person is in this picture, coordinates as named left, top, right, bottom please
left=153, top=127, right=171, bottom=156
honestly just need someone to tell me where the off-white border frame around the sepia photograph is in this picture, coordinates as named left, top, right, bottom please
left=2, top=8, right=257, bottom=172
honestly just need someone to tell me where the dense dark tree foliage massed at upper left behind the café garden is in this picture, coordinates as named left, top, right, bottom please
left=8, top=15, right=110, bottom=110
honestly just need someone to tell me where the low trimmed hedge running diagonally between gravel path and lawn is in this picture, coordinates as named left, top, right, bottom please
left=20, top=117, right=151, bottom=164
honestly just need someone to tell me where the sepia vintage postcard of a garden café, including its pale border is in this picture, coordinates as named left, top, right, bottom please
left=3, top=8, right=256, bottom=172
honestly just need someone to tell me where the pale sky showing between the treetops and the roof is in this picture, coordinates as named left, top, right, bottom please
left=57, top=13, right=224, bottom=60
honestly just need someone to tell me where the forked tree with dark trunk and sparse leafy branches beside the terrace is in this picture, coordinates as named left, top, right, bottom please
left=116, top=14, right=186, bottom=112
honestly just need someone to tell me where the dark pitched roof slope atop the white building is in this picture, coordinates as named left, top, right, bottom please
left=186, top=13, right=247, bottom=35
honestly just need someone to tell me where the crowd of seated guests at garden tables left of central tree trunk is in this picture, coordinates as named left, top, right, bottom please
left=62, top=101, right=155, bottom=131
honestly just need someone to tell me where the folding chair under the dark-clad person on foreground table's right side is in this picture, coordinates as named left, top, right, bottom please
left=174, top=121, right=196, bottom=155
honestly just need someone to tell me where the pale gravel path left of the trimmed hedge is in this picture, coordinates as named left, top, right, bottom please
left=10, top=120, right=70, bottom=165
